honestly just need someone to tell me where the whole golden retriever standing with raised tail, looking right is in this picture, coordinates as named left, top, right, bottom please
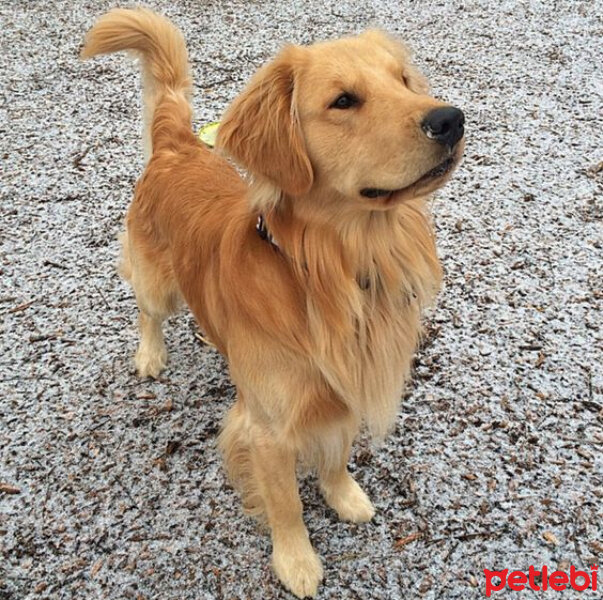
left=82, top=9, right=464, bottom=597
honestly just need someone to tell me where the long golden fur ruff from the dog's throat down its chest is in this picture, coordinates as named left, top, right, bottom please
left=265, top=190, right=440, bottom=436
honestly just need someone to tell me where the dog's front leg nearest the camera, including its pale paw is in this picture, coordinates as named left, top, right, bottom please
left=251, top=428, right=323, bottom=598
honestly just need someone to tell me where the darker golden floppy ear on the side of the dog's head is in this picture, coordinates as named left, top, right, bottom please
left=216, top=46, right=313, bottom=203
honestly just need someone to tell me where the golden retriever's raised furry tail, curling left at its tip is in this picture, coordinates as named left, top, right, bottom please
left=81, top=8, right=192, bottom=163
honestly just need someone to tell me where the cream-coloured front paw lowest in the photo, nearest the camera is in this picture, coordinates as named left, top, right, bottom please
left=272, top=539, right=323, bottom=598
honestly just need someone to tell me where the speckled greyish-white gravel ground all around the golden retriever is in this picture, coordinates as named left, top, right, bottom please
left=0, top=0, right=603, bottom=600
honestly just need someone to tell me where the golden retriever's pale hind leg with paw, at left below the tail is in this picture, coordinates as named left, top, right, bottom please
left=120, top=231, right=180, bottom=378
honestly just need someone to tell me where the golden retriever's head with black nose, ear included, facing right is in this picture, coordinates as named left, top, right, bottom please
left=218, top=31, right=464, bottom=210
